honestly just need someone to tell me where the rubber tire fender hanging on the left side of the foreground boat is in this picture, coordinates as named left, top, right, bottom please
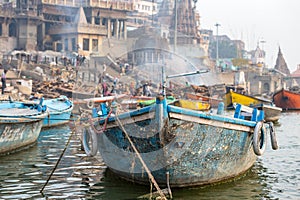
left=82, top=127, right=98, bottom=156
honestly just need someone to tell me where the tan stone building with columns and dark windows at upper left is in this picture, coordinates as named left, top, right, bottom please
left=0, top=0, right=133, bottom=55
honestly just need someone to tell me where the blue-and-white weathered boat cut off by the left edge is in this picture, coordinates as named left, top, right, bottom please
left=0, top=101, right=47, bottom=154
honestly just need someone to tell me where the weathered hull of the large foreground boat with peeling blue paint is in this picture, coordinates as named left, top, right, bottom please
left=97, top=106, right=257, bottom=187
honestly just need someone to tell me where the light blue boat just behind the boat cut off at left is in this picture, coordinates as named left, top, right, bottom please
left=43, top=96, right=74, bottom=128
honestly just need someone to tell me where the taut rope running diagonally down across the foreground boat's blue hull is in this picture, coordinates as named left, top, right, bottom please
left=115, top=112, right=167, bottom=199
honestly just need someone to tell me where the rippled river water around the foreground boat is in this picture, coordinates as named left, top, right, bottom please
left=0, top=112, right=300, bottom=200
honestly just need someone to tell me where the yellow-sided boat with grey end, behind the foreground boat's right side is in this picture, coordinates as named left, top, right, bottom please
left=226, top=90, right=282, bottom=122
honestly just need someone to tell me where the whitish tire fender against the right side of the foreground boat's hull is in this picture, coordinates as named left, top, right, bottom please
left=253, top=121, right=267, bottom=156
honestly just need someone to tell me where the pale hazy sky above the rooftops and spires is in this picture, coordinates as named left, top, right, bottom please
left=197, top=0, right=300, bottom=72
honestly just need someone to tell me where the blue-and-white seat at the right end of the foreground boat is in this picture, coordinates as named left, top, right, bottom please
left=234, top=104, right=264, bottom=122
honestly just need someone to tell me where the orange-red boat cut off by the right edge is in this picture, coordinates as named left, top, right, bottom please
left=273, top=89, right=300, bottom=110
